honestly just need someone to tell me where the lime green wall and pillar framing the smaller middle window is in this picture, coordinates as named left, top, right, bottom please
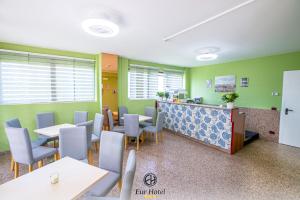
left=118, top=57, right=190, bottom=114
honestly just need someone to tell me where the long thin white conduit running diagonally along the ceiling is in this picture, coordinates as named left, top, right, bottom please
left=163, top=0, right=256, bottom=42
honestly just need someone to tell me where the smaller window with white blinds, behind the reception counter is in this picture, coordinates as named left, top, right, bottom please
left=128, top=65, right=184, bottom=99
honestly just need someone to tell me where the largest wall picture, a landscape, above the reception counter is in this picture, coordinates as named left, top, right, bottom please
left=215, top=75, right=236, bottom=92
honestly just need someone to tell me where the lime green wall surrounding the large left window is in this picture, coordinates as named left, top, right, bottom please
left=0, top=42, right=101, bottom=151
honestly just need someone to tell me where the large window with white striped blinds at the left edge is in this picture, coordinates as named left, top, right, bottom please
left=0, top=50, right=95, bottom=104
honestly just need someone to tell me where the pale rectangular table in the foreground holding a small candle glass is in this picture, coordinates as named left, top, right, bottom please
left=0, top=157, right=108, bottom=200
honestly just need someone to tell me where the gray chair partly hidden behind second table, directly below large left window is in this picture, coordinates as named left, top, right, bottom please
left=35, top=112, right=58, bottom=147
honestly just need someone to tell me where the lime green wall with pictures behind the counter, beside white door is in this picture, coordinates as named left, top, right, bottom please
left=190, top=52, right=300, bottom=109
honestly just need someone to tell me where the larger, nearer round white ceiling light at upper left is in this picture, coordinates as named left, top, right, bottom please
left=81, top=19, right=119, bottom=37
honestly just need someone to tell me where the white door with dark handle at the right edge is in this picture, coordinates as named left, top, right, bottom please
left=279, top=70, right=300, bottom=147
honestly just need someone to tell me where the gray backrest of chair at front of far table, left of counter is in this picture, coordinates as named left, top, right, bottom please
left=124, top=114, right=140, bottom=137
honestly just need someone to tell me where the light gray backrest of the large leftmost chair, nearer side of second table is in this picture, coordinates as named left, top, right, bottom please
left=5, top=127, right=33, bottom=165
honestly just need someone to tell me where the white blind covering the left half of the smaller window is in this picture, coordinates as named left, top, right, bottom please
left=128, top=66, right=159, bottom=99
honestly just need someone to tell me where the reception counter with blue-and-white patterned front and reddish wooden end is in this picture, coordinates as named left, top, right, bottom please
left=157, top=101, right=245, bottom=154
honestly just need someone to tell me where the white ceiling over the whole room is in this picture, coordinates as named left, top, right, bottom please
left=0, top=0, right=300, bottom=66
